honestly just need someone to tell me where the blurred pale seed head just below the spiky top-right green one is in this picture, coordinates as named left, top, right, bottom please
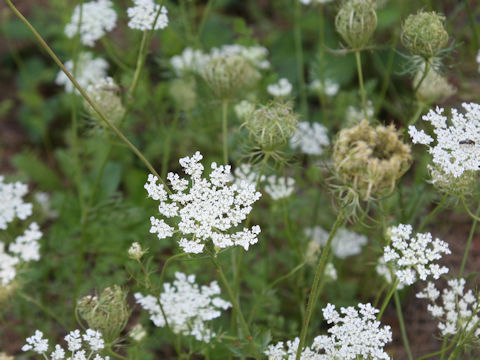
left=413, top=69, right=457, bottom=104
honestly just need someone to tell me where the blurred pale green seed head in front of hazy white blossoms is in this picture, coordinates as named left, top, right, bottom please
left=203, top=55, right=261, bottom=99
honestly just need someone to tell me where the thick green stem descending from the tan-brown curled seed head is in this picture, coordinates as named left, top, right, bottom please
left=296, top=213, right=344, bottom=360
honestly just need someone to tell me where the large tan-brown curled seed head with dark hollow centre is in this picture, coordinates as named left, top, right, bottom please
left=333, top=120, right=412, bottom=201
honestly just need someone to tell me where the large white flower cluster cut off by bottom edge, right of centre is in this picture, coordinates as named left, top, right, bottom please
left=265, top=304, right=392, bottom=360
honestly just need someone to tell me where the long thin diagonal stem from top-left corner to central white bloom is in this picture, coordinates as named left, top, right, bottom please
left=5, top=0, right=170, bottom=191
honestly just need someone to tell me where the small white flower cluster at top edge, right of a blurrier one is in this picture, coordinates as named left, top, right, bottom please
left=127, top=0, right=168, bottom=31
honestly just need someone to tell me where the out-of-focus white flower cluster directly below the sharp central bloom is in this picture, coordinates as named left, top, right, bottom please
left=135, top=272, right=232, bottom=343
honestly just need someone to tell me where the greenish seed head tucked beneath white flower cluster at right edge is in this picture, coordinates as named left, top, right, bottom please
left=428, top=165, right=478, bottom=198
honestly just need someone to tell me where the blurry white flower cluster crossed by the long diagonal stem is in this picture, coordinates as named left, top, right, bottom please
left=55, top=52, right=108, bottom=93
